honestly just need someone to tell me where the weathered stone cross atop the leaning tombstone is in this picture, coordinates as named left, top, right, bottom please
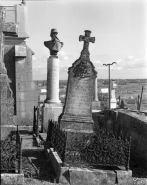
left=79, top=30, right=95, bottom=60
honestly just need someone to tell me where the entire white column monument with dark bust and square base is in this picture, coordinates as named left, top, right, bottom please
left=43, top=29, right=63, bottom=130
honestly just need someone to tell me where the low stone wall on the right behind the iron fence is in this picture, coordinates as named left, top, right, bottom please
left=93, top=110, right=147, bottom=168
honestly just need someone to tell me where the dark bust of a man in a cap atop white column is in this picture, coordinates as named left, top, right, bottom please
left=44, top=29, right=63, bottom=55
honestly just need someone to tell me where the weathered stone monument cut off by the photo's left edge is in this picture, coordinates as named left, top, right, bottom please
left=0, top=7, right=14, bottom=125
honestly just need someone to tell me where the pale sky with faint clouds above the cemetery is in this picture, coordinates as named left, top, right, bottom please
left=2, top=0, right=147, bottom=80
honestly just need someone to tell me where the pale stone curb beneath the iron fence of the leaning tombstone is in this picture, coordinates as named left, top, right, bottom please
left=44, top=143, right=132, bottom=185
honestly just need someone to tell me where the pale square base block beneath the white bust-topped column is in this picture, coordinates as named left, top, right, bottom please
left=42, top=103, right=63, bottom=131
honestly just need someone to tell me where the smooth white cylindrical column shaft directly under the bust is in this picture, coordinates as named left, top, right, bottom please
left=45, top=55, right=61, bottom=103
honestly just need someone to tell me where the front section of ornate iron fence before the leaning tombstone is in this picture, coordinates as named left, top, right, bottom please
left=65, top=127, right=131, bottom=170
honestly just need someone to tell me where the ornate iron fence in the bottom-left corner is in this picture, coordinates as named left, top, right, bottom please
left=0, top=126, right=22, bottom=174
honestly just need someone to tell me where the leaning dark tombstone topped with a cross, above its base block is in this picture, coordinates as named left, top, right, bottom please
left=59, top=30, right=97, bottom=130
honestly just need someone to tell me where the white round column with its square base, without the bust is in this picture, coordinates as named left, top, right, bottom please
left=43, top=55, right=63, bottom=130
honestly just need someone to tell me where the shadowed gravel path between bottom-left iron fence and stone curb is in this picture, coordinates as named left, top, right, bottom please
left=21, top=134, right=56, bottom=185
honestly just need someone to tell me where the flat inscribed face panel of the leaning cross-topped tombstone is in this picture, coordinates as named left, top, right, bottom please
left=65, top=78, right=93, bottom=116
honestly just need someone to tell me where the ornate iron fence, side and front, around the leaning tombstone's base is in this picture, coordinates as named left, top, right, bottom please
left=47, top=120, right=131, bottom=170
